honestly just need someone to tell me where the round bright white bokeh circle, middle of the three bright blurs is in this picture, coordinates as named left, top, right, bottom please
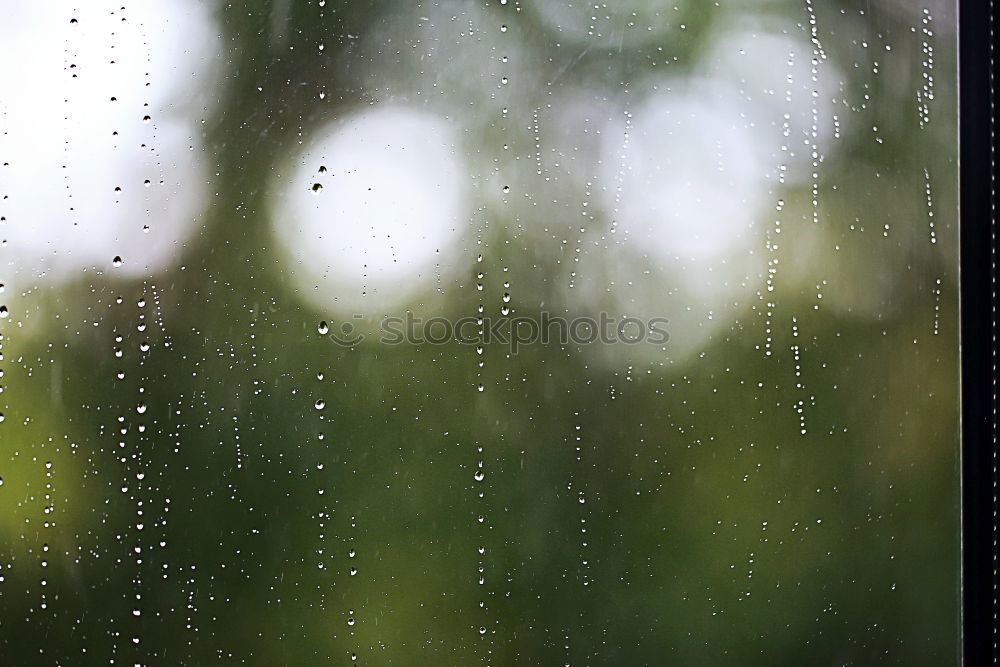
left=273, top=106, right=471, bottom=316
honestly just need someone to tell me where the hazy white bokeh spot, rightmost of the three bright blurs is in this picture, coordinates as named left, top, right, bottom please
left=601, top=82, right=767, bottom=262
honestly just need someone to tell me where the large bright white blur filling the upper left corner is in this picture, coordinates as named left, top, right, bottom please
left=0, top=0, right=220, bottom=288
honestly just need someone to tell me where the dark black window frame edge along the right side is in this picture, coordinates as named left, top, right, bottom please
left=958, top=0, right=1000, bottom=665
